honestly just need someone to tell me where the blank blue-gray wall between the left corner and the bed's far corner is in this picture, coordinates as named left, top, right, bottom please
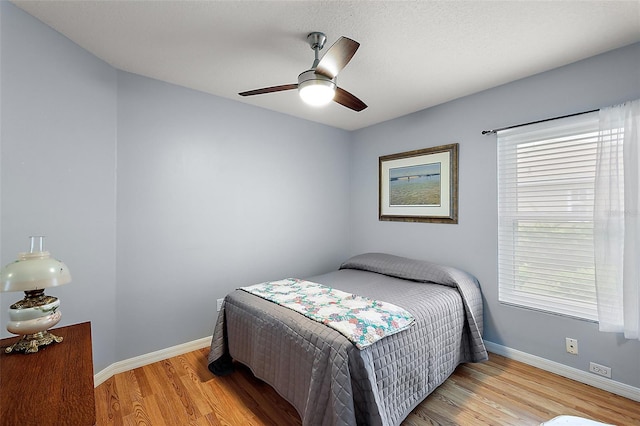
left=117, top=73, right=349, bottom=359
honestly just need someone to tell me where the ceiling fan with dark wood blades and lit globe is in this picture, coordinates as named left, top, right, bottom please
left=238, top=31, right=367, bottom=112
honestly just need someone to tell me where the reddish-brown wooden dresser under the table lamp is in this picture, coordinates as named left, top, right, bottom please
left=0, top=322, right=96, bottom=426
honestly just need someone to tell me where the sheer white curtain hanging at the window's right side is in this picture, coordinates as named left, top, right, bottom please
left=594, top=99, right=640, bottom=339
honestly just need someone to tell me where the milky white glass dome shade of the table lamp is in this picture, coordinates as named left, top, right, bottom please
left=0, top=251, right=71, bottom=292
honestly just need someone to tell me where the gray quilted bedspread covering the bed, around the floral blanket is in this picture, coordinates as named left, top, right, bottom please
left=209, top=253, right=488, bottom=425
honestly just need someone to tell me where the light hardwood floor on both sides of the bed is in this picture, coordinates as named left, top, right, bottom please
left=95, top=349, right=640, bottom=426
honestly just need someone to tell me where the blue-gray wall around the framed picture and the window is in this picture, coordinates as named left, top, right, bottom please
left=351, top=44, right=640, bottom=387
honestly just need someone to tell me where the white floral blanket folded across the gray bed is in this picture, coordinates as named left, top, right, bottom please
left=241, top=278, right=414, bottom=349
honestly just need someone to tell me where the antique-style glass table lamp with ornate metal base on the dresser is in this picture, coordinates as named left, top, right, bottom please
left=0, top=237, right=71, bottom=353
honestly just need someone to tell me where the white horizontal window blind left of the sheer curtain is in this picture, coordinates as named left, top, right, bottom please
left=498, top=113, right=598, bottom=320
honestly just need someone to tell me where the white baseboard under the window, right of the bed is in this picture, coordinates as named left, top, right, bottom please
left=484, top=340, right=640, bottom=402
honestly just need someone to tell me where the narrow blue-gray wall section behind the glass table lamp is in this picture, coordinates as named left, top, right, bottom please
left=0, top=1, right=117, bottom=367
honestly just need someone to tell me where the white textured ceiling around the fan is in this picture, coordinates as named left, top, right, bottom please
left=13, top=0, right=640, bottom=130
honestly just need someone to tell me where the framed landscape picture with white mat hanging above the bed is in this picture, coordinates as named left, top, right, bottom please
left=378, top=143, right=458, bottom=223
